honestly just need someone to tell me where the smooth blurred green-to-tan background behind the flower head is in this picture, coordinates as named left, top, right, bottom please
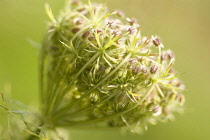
left=0, top=0, right=210, bottom=140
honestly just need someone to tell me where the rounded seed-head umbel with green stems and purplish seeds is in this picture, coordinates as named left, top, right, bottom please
left=40, top=0, right=185, bottom=132
